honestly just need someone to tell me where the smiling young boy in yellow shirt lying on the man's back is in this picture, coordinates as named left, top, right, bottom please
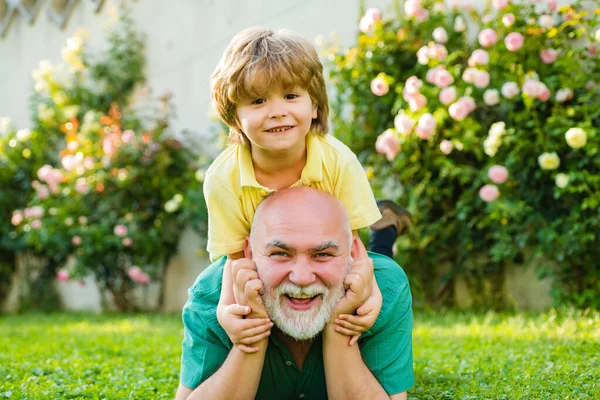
left=204, top=27, right=406, bottom=352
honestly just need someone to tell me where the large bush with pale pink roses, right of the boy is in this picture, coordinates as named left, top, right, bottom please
left=324, top=0, right=600, bottom=306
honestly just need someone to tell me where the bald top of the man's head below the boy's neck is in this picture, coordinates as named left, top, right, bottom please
left=250, top=186, right=352, bottom=252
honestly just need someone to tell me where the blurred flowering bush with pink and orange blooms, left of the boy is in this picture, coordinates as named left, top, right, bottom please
left=5, top=7, right=206, bottom=310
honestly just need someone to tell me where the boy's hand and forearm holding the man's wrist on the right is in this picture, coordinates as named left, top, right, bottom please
left=334, top=279, right=383, bottom=346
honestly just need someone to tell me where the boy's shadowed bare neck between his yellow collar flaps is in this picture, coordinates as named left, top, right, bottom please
left=250, top=141, right=307, bottom=190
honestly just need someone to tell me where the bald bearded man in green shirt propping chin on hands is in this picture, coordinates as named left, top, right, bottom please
left=177, top=187, right=414, bottom=400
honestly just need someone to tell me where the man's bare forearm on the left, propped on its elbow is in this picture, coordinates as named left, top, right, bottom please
left=175, top=339, right=268, bottom=400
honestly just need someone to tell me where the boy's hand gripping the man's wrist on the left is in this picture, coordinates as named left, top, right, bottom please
left=221, top=304, right=273, bottom=353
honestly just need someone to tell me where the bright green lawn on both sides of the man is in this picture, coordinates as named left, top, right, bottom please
left=0, top=310, right=600, bottom=399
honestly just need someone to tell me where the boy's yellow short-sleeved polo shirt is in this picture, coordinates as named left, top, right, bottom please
left=204, top=133, right=381, bottom=260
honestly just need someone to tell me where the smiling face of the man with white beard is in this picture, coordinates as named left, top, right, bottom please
left=251, top=208, right=352, bottom=340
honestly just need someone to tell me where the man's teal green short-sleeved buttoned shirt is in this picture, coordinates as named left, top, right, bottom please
left=180, top=252, right=414, bottom=400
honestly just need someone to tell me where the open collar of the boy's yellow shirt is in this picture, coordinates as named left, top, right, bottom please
left=237, top=132, right=323, bottom=188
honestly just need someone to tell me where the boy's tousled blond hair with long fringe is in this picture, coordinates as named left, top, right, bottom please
left=210, top=27, right=329, bottom=141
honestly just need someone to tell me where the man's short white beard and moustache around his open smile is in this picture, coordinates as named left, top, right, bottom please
left=262, top=283, right=345, bottom=340
